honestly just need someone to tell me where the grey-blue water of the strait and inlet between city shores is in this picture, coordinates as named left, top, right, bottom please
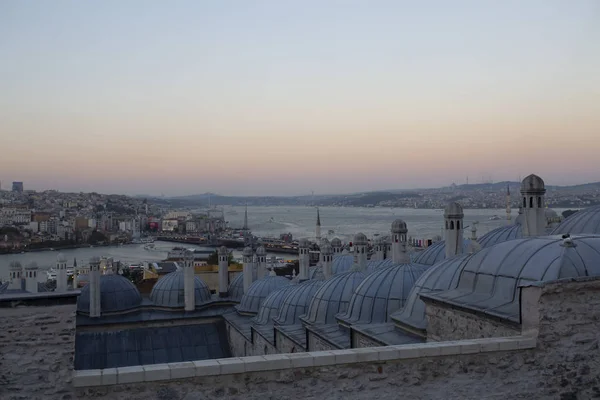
left=0, top=206, right=563, bottom=280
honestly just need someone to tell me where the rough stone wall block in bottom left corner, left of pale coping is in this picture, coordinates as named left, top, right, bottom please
left=0, top=304, right=75, bottom=400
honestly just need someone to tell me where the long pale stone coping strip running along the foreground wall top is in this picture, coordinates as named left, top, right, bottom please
left=73, top=335, right=537, bottom=387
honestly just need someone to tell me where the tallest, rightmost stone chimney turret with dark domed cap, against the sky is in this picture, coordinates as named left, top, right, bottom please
left=521, top=174, right=546, bottom=236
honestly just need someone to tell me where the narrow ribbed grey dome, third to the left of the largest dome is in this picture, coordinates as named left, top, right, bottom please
left=302, top=271, right=367, bottom=325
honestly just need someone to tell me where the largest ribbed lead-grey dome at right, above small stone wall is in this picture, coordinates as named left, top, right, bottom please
left=430, top=235, right=600, bottom=322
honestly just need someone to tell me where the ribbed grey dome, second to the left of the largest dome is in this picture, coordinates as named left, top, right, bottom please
left=338, top=264, right=426, bottom=324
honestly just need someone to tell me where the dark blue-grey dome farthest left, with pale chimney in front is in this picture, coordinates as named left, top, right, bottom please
left=77, top=274, right=142, bottom=314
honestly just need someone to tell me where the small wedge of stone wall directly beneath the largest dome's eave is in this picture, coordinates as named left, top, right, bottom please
left=423, top=297, right=521, bottom=341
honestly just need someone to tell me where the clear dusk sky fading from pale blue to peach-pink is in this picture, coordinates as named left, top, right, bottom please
left=0, top=0, right=600, bottom=195
